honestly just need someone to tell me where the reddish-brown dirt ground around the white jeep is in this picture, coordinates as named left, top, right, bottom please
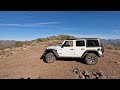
left=0, top=40, right=120, bottom=79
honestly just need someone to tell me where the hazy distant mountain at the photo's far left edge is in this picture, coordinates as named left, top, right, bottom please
left=0, top=40, right=17, bottom=49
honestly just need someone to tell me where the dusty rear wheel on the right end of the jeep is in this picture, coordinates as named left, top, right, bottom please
left=85, top=53, right=98, bottom=65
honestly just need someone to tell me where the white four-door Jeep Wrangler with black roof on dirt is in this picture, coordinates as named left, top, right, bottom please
left=41, top=38, right=104, bottom=65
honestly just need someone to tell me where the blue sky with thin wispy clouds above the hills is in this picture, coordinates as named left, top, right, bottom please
left=0, top=11, right=120, bottom=41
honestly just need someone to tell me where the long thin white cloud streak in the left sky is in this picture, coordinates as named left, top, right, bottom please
left=0, top=22, right=59, bottom=26
